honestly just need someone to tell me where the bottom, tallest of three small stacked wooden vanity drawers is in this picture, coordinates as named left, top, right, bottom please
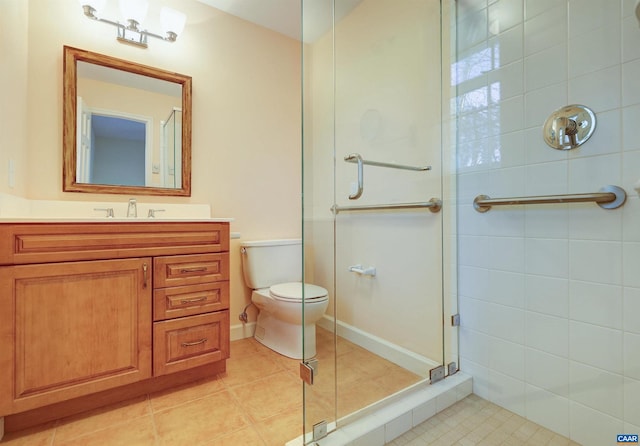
left=153, top=310, right=229, bottom=376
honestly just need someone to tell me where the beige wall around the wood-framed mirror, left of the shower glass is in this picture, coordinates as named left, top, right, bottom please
left=0, top=0, right=301, bottom=328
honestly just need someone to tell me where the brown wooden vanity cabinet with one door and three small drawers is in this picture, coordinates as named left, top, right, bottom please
left=0, top=222, right=229, bottom=417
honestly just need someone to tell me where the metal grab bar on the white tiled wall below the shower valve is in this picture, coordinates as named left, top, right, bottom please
left=473, top=185, right=627, bottom=212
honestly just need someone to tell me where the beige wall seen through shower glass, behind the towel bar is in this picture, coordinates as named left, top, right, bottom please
left=304, top=0, right=443, bottom=362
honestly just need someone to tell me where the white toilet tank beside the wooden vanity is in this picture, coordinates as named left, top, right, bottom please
left=240, top=239, right=302, bottom=289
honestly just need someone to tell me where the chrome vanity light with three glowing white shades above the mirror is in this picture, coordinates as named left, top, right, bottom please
left=79, top=0, right=186, bottom=48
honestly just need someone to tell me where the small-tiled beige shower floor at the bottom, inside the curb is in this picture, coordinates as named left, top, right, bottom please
left=389, top=394, right=579, bottom=446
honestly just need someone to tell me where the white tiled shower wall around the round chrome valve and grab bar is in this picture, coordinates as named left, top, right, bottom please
left=452, top=0, right=640, bottom=445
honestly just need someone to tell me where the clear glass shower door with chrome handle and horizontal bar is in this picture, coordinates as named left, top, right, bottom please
left=302, top=0, right=450, bottom=444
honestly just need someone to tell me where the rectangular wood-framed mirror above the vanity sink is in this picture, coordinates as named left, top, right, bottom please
left=62, top=46, right=191, bottom=196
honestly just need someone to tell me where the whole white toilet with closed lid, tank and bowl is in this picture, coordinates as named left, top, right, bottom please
left=240, top=239, right=329, bottom=359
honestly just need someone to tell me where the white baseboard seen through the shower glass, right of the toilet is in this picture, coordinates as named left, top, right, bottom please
left=317, top=314, right=440, bottom=378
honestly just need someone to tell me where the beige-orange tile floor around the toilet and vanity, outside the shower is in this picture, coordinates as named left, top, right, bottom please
left=0, top=329, right=421, bottom=446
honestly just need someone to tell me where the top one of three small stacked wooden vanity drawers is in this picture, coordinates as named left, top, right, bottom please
left=153, top=252, right=229, bottom=288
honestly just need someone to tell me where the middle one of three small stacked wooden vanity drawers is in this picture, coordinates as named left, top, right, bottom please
left=153, top=281, right=229, bottom=321
